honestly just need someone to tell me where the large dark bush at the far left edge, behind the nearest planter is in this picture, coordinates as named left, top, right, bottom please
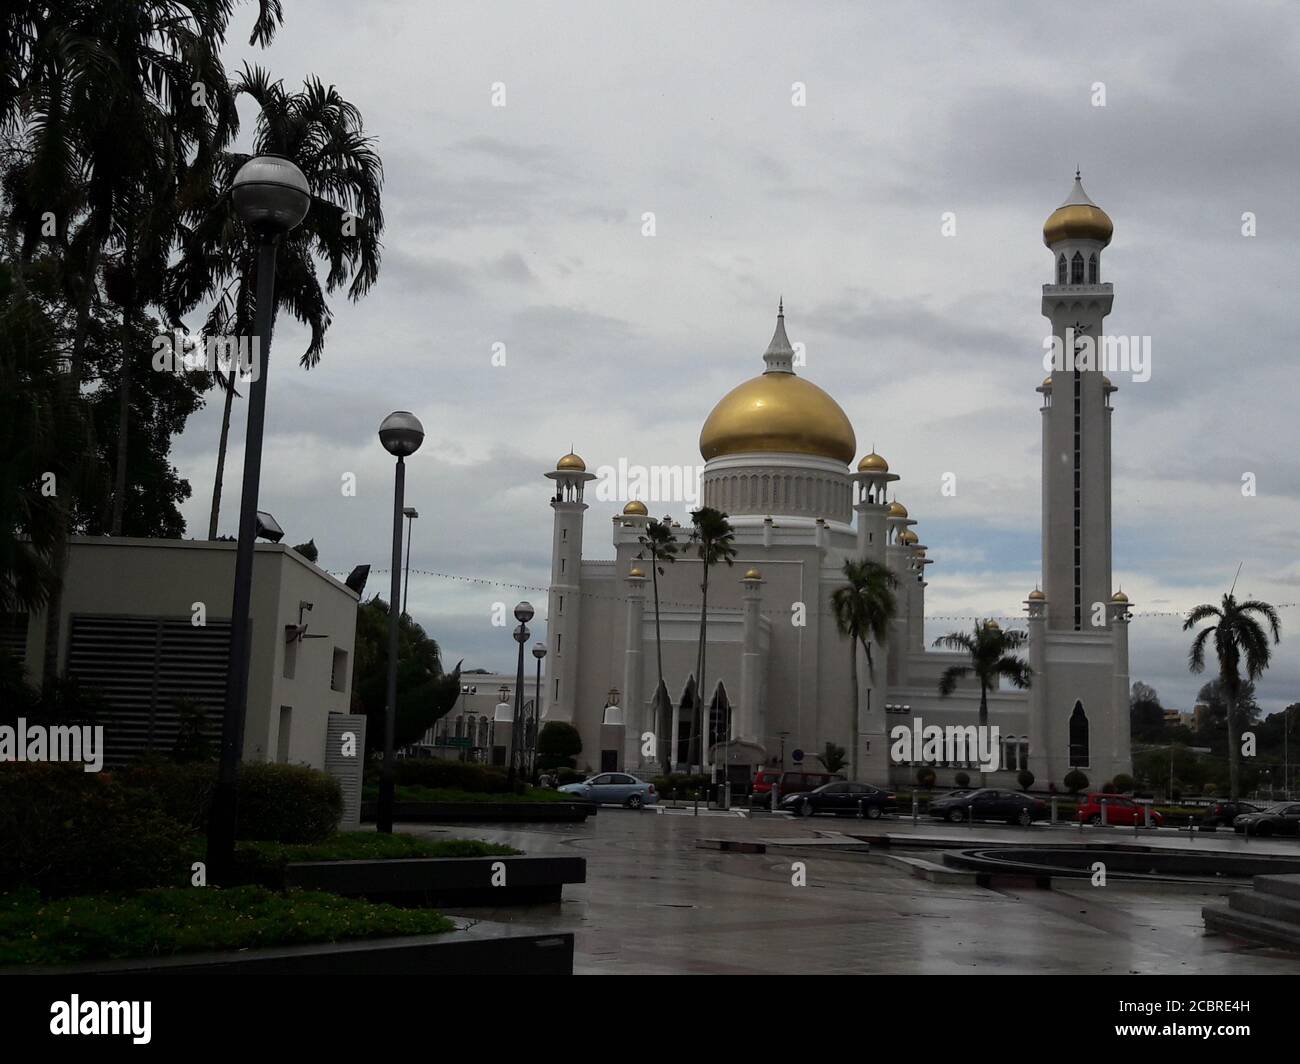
left=0, top=764, right=192, bottom=898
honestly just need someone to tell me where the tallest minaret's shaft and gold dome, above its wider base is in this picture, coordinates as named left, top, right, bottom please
left=1039, top=172, right=1114, bottom=631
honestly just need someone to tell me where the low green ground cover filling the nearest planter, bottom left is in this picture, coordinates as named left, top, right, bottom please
left=0, top=887, right=455, bottom=965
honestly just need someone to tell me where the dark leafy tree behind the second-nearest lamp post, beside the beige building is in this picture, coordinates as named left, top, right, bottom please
left=352, top=596, right=460, bottom=752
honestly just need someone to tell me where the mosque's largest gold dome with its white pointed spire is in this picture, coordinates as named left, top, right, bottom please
left=699, top=304, right=858, bottom=466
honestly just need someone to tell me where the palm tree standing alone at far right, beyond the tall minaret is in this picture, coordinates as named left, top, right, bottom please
left=1183, top=591, right=1282, bottom=799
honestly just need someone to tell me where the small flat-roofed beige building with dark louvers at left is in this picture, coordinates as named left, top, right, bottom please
left=12, top=536, right=364, bottom=769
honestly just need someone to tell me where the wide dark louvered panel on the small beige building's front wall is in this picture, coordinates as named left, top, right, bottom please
left=68, top=614, right=230, bottom=765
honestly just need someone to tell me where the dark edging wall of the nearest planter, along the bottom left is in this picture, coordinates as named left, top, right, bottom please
left=0, top=924, right=573, bottom=976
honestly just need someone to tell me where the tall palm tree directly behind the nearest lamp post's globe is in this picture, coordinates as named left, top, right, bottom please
left=169, top=65, right=384, bottom=539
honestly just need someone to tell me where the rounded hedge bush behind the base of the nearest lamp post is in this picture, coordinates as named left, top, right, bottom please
left=121, top=761, right=343, bottom=843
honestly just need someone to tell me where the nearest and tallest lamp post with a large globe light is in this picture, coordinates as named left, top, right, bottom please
left=207, top=155, right=312, bottom=883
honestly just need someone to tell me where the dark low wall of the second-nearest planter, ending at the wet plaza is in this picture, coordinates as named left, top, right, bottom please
left=283, top=856, right=586, bottom=907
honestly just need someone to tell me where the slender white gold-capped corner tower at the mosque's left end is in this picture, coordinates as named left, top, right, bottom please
left=546, top=451, right=595, bottom=722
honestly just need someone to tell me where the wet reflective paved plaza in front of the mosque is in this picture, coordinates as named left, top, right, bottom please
left=398, top=809, right=1300, bottom=974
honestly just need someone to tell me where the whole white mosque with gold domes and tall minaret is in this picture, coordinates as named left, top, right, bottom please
left=533, top=174, right=1132, bottom=790
